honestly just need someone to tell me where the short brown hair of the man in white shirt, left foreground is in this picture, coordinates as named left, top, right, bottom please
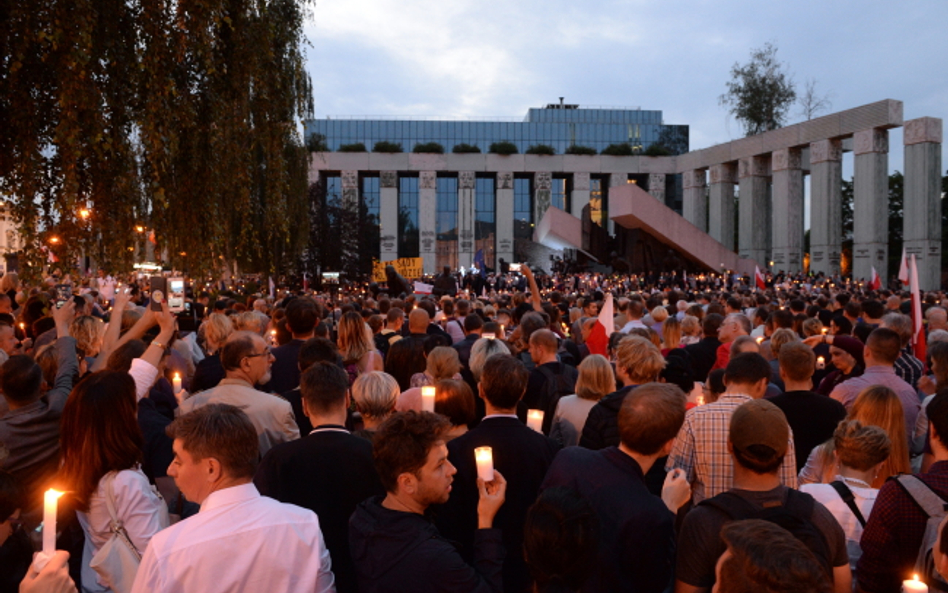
left=165, top=404, right=260, bottom=478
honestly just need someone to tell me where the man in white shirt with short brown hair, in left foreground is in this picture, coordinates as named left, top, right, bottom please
left=132, top=404, right=335, bottom=593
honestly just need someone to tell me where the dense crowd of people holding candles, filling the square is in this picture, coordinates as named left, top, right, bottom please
left=0, top=266, right=948, bottom=593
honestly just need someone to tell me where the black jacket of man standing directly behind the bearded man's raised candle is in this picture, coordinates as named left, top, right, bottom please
left=434, top=417, right=559, bottom=593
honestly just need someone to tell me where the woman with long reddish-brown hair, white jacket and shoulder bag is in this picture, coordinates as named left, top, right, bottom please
left=56, top=371, right=169, bottom=591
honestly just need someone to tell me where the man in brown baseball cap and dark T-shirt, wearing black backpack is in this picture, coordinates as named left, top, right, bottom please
left=675, top=399, right=852, bottom=593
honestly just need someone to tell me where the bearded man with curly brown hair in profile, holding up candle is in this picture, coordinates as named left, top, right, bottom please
left=349, top=410, right=508, bottom=593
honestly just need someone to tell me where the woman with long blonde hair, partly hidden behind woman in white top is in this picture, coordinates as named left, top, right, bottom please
left=799, top=385, right=912, bottom=488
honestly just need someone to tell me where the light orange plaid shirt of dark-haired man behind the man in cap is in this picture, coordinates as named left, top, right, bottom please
left=665, top=393, right=797, bottom=504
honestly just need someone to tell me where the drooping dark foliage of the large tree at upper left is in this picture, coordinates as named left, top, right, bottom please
left=0, top=0, right=312, bottom=272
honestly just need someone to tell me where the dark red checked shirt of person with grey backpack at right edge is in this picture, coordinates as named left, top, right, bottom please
left=856, top=461, right=948, bottom=593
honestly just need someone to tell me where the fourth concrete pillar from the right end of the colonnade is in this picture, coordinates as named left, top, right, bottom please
left=771, top=148, right=803, bottom=272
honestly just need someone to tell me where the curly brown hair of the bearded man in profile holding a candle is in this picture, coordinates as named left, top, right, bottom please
left=372, top=410, right=451, bottom=492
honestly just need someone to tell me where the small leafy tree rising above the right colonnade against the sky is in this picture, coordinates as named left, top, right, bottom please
left=719, top=43, right=797, bottom=136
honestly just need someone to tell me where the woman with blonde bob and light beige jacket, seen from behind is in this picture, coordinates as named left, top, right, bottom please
left=550, top=354, right=616, bottom=447
